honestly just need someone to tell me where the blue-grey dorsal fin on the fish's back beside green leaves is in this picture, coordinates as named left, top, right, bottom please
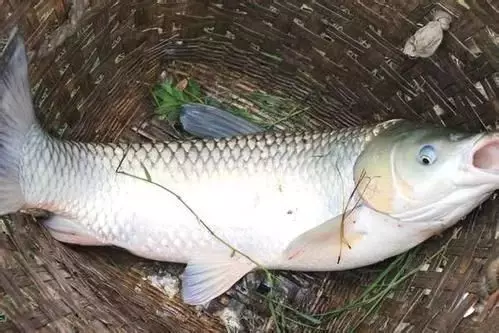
left=180, top=103, right=263, bottom=138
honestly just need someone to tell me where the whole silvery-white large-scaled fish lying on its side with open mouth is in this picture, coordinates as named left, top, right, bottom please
left=0, top=30, right=499, bottom=305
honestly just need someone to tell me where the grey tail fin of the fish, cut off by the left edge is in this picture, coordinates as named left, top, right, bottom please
left=0, top=28, right=36, bottom=215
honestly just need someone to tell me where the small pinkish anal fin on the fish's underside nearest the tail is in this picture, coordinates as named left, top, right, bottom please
left=43, top=215, right=108, bottom=246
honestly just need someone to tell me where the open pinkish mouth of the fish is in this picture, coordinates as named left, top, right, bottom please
left=471, top=136, right=499, bottom=174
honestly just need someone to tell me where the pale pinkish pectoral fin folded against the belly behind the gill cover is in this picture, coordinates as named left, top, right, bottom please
left=284, top=207, right=365, bottom=260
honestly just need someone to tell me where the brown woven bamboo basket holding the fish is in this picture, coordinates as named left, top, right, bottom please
left=0, top=0, right=499, bottom=333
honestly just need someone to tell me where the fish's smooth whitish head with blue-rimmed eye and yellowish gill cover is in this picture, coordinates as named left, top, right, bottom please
left=354, top=121, right=499, bottom=229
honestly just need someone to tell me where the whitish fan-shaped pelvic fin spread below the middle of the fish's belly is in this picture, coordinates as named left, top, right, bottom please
left=182, top=253, right=256, bottom=305
